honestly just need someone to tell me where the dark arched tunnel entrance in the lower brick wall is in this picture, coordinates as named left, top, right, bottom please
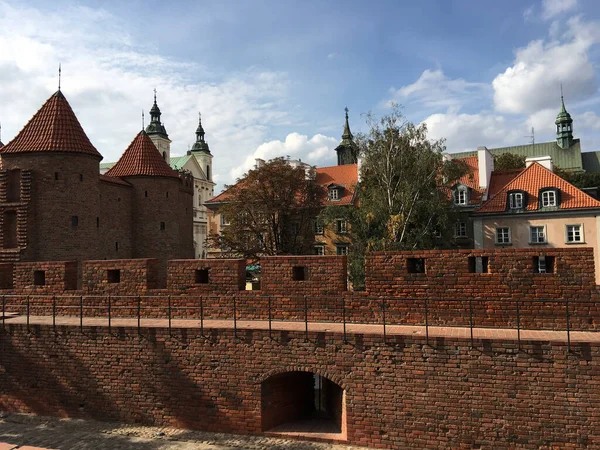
left=261, top=371, right=346, bottom=439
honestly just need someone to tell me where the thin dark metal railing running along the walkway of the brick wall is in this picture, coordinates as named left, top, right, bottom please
left=2, top=295, right=600, bottom=350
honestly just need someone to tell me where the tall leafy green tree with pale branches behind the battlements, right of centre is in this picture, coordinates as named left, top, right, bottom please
left=321, top=107, right=467, bottom=288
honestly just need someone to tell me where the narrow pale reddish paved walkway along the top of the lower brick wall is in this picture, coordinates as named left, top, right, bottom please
left=5, top=315, right=600, bottom=342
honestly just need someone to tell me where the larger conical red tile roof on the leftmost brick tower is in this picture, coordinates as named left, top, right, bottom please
left=0, top=91, right=102, bottom=158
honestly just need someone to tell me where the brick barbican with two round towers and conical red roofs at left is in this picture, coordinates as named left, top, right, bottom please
left=0, top=90, right=193, bottom=284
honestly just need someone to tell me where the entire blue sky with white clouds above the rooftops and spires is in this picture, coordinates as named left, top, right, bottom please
left=0, top=0, right=600, bottom=193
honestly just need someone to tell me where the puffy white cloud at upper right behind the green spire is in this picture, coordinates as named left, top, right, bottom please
left=492, top=18, right=600, bottom=114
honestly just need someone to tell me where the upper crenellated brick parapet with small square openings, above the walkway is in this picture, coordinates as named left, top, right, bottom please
left=0, top=248, right=600, bottom=330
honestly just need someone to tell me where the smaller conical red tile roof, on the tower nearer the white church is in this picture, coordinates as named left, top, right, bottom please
left=106, top=131, right=179, bottom=178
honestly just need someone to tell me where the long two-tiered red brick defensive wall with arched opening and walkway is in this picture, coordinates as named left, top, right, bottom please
left=0, top=249, right=600, bottom=449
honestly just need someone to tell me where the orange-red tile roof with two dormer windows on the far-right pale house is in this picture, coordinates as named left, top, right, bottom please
left=476, top=163, right=600, bottom=213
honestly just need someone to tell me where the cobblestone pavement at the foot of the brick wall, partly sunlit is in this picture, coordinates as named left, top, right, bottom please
left=0, top=414, right=365, bottom=450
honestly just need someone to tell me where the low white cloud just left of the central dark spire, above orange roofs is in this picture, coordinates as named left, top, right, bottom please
left=231, top=133, right=339, bottom=178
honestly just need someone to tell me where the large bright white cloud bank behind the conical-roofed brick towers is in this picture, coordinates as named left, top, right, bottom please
left=0, top=0, right=290, bottom=187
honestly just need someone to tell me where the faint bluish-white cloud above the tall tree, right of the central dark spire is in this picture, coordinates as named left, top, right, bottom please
left=391, top=69, right=489, bottom=110
